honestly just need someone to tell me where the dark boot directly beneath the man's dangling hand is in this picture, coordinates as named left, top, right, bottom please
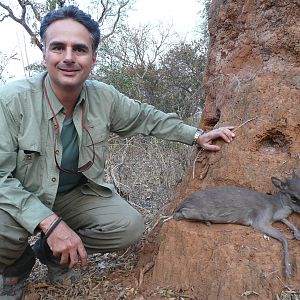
left=33, top=238, right=79, bottom=285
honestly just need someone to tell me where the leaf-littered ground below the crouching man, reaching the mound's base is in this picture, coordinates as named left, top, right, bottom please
left=24, top=224, right=185, bottom=300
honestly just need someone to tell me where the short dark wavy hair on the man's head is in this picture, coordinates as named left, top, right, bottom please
left=40, top=5, right=100, bottom=52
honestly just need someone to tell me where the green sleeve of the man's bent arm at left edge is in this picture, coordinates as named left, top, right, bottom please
left=0, top=101, right=53, bottom=234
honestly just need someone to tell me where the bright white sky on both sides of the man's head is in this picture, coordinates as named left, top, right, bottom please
left=0, top=0, right=200, bottom=78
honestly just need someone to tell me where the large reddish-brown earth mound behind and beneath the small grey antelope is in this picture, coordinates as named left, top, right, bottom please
left=141, top=0, right=300, bottom=300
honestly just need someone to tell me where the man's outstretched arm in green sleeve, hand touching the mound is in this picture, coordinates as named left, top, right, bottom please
left=111, top=93, right=235, bottom=151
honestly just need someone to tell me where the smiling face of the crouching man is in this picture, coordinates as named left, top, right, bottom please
left=43, top=19, right=96, bottom=93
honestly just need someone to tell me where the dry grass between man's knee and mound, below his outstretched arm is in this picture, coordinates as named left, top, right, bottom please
left=107, top=136, right=194, bottom=231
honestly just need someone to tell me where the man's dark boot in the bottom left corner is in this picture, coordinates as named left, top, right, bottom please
left=0, top=245, right=35, bottom=300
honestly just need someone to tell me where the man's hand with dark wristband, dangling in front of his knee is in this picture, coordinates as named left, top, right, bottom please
left=39, top=215, right=88, bottom=270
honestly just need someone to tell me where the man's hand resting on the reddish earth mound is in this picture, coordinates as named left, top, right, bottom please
left=196, top=126, right=235, bottom=151
